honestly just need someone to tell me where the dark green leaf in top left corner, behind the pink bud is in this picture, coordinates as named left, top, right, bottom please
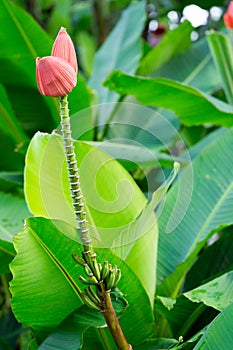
left=0, top=0, right=59, bottom=131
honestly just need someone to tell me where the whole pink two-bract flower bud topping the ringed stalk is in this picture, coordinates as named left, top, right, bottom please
left=36, top=27, right=78, bottom=97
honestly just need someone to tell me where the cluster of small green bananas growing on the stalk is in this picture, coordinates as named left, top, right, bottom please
left=73, top=254, right=121, bottom=311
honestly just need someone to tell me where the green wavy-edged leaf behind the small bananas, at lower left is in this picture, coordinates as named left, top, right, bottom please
left=11, top=218, right=154, bottom=344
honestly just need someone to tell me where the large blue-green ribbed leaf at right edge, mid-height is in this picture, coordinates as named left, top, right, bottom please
left=158, top=130, right=233, bottom=295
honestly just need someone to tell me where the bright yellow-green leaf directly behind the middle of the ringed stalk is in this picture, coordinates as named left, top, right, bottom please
left=25, top=133, right=146, bottom=234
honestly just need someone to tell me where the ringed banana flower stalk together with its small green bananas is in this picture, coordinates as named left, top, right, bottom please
left=60, top=96, right=132, bottom=350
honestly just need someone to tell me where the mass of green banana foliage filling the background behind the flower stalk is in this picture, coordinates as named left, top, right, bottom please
left=0, top=0, right=233, bottom=350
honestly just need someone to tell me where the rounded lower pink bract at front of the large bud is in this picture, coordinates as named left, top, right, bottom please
left=36, top=56, right=77, bottom=97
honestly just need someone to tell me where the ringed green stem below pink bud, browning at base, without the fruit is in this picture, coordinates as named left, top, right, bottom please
left=60, top=96, right=132, bottom=350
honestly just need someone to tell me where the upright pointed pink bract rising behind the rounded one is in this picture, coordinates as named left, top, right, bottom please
left=52, top=27, right=78, bottom=73
